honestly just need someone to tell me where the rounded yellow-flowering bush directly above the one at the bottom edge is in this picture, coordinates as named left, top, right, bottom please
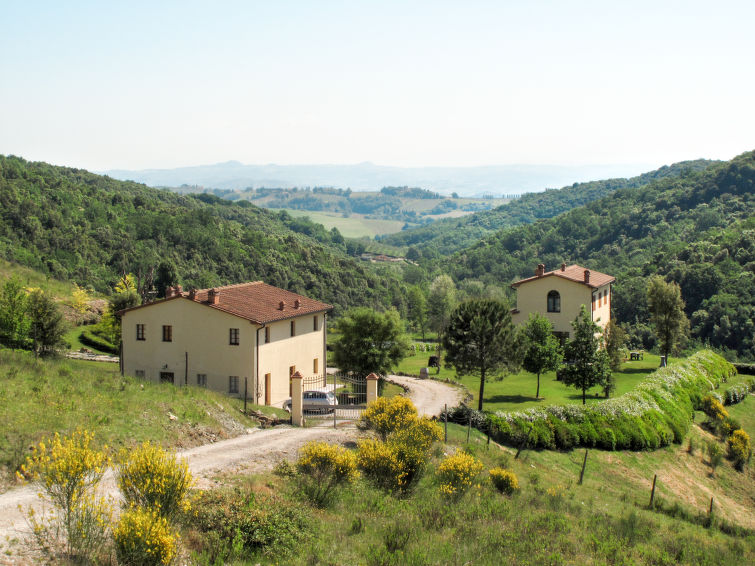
left=118, top=442, right=192, bottom=520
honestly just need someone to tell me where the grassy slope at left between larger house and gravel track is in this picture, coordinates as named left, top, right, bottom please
left=0, top=350, right=285, bottom=487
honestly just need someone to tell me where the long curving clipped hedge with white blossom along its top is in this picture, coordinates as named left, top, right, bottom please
left=448, top=350, right=736, bottom=450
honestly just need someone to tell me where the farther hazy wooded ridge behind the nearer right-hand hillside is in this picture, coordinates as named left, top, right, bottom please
left=381, top=159, right=716, bottom=257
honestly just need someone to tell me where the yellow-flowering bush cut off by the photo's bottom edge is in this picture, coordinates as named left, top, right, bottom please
left=113, top=507, right=179, bottom=566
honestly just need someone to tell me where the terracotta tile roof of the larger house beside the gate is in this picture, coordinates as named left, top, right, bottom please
left=121, top=281, right=333, bottom=324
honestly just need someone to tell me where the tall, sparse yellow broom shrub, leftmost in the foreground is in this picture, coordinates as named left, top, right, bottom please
left=21, top=430, right=112, bottom=561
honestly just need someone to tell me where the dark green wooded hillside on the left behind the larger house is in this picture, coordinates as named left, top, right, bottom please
left=0, top=156, right=405, bottom=312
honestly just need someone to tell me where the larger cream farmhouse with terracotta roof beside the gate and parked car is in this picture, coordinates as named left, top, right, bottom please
left=121, top=281, right=332, bottom=405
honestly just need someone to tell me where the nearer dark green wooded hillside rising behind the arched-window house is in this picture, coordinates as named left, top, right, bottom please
left=443, top=152, right=755, bottom=360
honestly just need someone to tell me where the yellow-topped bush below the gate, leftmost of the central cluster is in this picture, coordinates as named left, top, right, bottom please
left=296, top=442, right=359, bottom=506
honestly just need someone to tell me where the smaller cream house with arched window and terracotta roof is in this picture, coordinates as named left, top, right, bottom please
left=511, top=263, right=616, bottom=339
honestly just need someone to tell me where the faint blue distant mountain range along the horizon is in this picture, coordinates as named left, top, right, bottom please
left=102, top=161, right=652, bottom=196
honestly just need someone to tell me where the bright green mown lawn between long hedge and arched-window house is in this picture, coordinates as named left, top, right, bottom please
left=397, top=346, right=674, bottom=411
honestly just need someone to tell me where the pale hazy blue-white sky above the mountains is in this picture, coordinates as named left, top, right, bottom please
left=0, top=0, right=755, bottom=170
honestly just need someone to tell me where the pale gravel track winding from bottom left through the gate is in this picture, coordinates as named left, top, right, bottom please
left=0, top=376, right=462, bottom=564
